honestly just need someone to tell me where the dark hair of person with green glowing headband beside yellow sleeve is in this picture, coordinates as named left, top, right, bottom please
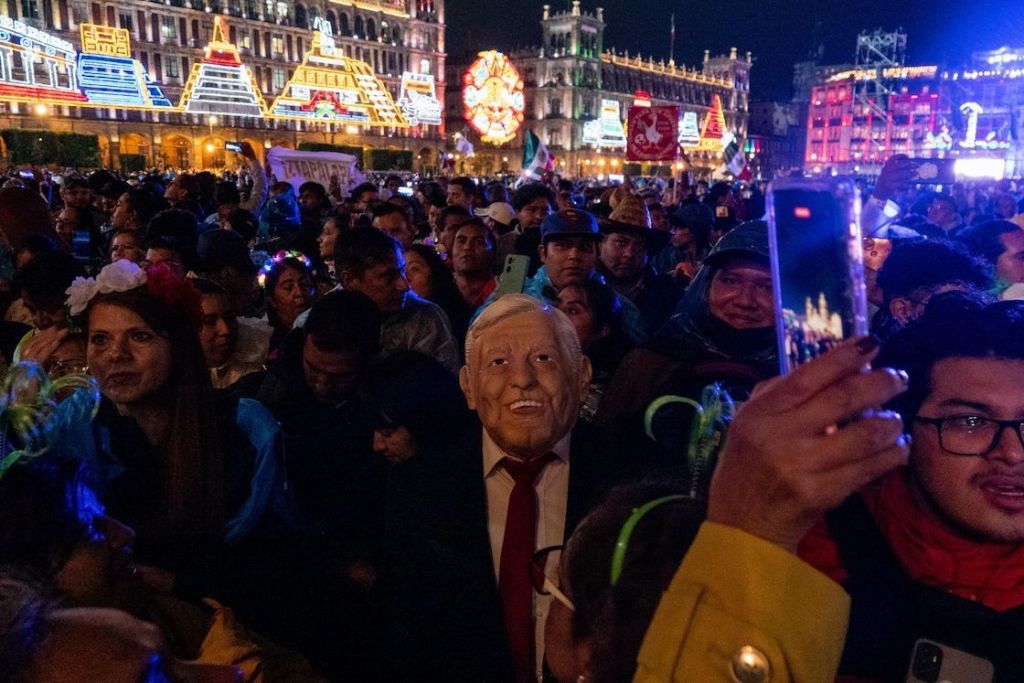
left=560, top=481, right=705, bottom=683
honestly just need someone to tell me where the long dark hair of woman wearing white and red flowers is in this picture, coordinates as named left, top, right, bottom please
left=84, top=264, right=224, bottom=540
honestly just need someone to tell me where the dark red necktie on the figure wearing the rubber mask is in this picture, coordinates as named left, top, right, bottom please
left=498, top=453, right=556, bottom=681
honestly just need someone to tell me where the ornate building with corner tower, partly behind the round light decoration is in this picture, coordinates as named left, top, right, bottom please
left=445, top=0, right=752, bottom=176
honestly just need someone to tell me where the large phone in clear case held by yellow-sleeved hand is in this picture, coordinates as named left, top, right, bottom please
left=767, top=177, right=867, bottom=375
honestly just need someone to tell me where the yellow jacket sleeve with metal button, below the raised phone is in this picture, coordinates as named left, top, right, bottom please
left=633, top=522, right=850, bottom=683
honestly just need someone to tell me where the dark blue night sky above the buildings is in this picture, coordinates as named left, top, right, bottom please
left=444, top=0, right=1024, bottom=100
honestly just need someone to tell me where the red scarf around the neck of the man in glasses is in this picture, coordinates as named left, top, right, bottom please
left=865, top=470, right=1024, bottom=611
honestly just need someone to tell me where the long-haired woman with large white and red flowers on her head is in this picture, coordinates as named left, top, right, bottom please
left=68, top=261, right=294, bottom=572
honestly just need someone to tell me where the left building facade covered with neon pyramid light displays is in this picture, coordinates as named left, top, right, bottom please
left=0, top=0, right=445, bottom=169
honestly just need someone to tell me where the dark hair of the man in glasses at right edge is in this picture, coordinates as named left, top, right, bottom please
left=874, top=292, right=1024, bottom=420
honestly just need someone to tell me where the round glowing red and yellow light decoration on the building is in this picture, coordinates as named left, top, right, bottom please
left=462, top=50, right=525, bottom=144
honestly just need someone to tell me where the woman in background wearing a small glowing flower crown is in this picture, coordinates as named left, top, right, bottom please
left=258, top=251, right=316, bottom=354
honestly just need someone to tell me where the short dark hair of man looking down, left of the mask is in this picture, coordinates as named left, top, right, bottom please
left=303, top=290, right=381, bottom=358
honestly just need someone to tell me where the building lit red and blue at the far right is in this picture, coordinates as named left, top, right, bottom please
left=804, top=48, right=1024, bottom=176
